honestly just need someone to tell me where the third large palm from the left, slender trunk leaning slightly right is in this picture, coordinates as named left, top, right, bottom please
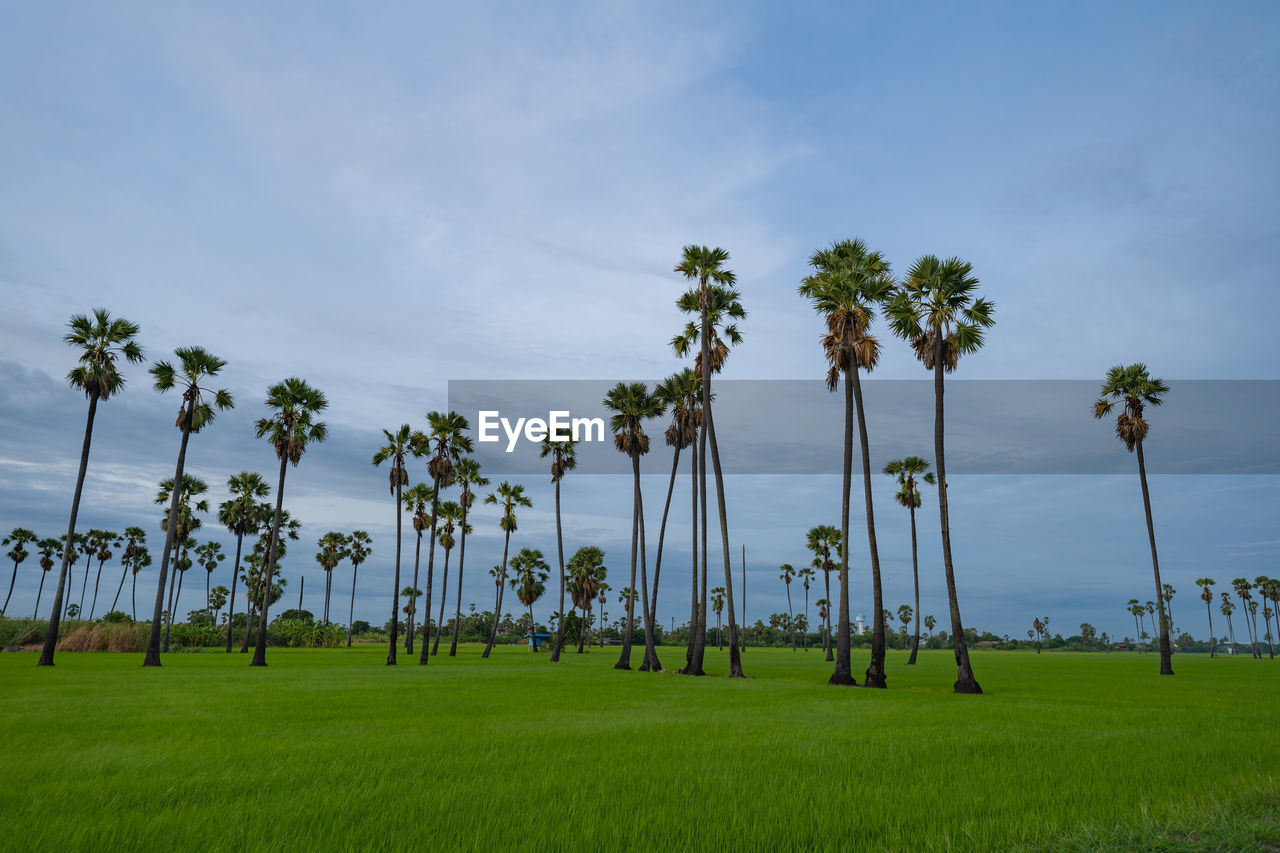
left=250, top=377, right=329, bottom=666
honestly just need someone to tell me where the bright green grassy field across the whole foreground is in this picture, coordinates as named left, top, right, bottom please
left=0, top=646, right=1280, bottom=852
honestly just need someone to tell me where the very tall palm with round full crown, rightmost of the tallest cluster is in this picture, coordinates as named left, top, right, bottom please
left=887, top=255, right=995, bottom=693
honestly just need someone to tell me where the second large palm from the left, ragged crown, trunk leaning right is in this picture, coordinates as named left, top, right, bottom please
left=142, top=347, right=236, bottom=666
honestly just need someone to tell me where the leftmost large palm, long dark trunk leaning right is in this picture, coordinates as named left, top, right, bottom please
left=36, top=309, right=142, bottom=666
